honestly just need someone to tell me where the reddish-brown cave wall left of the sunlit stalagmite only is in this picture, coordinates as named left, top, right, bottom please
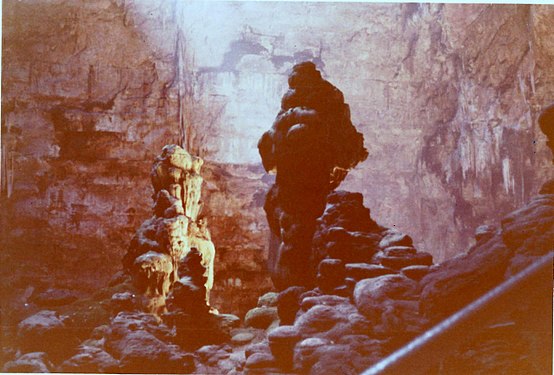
left=2, top=1, right=179, bottom=288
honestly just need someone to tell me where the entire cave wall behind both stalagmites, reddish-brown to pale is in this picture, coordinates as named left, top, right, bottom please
left=1, top=0, right=554, bottom=311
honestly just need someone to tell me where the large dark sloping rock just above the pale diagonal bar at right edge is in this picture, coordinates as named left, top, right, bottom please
left=420, top=196, right=554, bottom=322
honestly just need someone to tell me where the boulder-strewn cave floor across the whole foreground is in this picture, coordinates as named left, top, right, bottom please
left=2, top=184, right=554, bottom=374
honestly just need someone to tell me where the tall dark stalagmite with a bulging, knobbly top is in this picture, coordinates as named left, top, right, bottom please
left=258, top=62, right=368, bottom=289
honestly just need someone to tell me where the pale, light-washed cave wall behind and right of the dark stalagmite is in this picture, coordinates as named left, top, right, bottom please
left=170, top=2, right=554, bottom=260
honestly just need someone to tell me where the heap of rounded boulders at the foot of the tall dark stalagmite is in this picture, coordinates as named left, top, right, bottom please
left=245, top=191, right=432, bottom=374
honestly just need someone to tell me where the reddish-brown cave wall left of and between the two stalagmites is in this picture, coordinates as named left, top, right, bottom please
left=0, top=0, right=271, bottom=318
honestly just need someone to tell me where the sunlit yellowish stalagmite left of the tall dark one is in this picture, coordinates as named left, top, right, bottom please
left=123, top=145, right=215, bottom=313
